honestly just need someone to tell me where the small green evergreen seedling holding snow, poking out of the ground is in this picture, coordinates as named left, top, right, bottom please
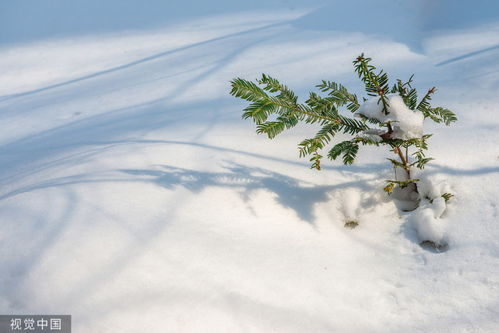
left=230, top=54, right=457, bottom=194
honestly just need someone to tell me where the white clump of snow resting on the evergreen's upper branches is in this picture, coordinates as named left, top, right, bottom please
left=355, top=94, right=424, bottom=140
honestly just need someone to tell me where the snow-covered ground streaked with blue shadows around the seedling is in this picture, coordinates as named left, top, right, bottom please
left=0, top=0, right=499, bottom=332
